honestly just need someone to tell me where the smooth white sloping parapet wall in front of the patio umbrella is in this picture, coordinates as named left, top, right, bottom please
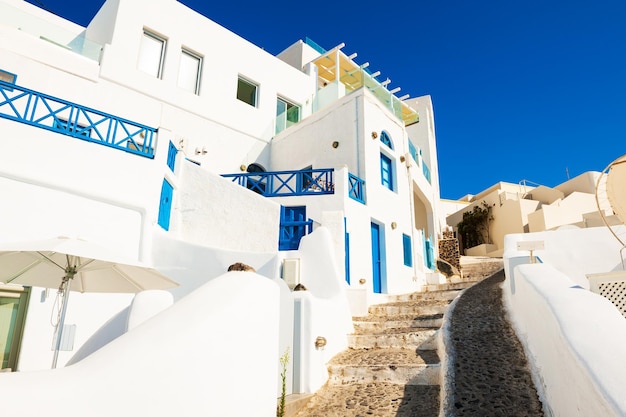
left=0, top=272, right=279, bottom=417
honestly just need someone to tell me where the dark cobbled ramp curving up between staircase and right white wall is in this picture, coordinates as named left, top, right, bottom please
left=444, top=271, right=544, bottom=417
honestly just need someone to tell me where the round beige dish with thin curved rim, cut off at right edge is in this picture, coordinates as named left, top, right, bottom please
left=596, top=155, right=626, bottom=269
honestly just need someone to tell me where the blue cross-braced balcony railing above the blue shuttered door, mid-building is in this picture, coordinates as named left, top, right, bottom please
left=222, top=168, right=335, bottom=197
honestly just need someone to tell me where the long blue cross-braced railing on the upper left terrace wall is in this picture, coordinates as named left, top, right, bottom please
left=0, top=81, right=156, bottom=158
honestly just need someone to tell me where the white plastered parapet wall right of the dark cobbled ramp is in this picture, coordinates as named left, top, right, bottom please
left=503, top=228, right=626, bottom=417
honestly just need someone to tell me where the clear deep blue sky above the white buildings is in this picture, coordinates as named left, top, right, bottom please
left=29, top=0, right=626, bottom=199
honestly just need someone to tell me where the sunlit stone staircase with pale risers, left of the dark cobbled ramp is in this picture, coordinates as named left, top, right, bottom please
left=294, top=280, right=476, bottom=417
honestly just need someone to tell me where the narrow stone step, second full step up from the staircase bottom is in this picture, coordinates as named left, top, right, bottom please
left=348, top=328, right=438, bottom=350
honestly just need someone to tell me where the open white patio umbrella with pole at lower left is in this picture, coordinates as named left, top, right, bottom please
left=0, top=236, right=178, bottom=368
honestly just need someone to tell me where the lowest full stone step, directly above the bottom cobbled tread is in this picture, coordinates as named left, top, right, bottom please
left=328, top=348, right=440, bottom=385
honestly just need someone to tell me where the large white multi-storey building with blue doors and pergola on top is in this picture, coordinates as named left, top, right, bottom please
left=0, top=0, right=442, bottom=411
